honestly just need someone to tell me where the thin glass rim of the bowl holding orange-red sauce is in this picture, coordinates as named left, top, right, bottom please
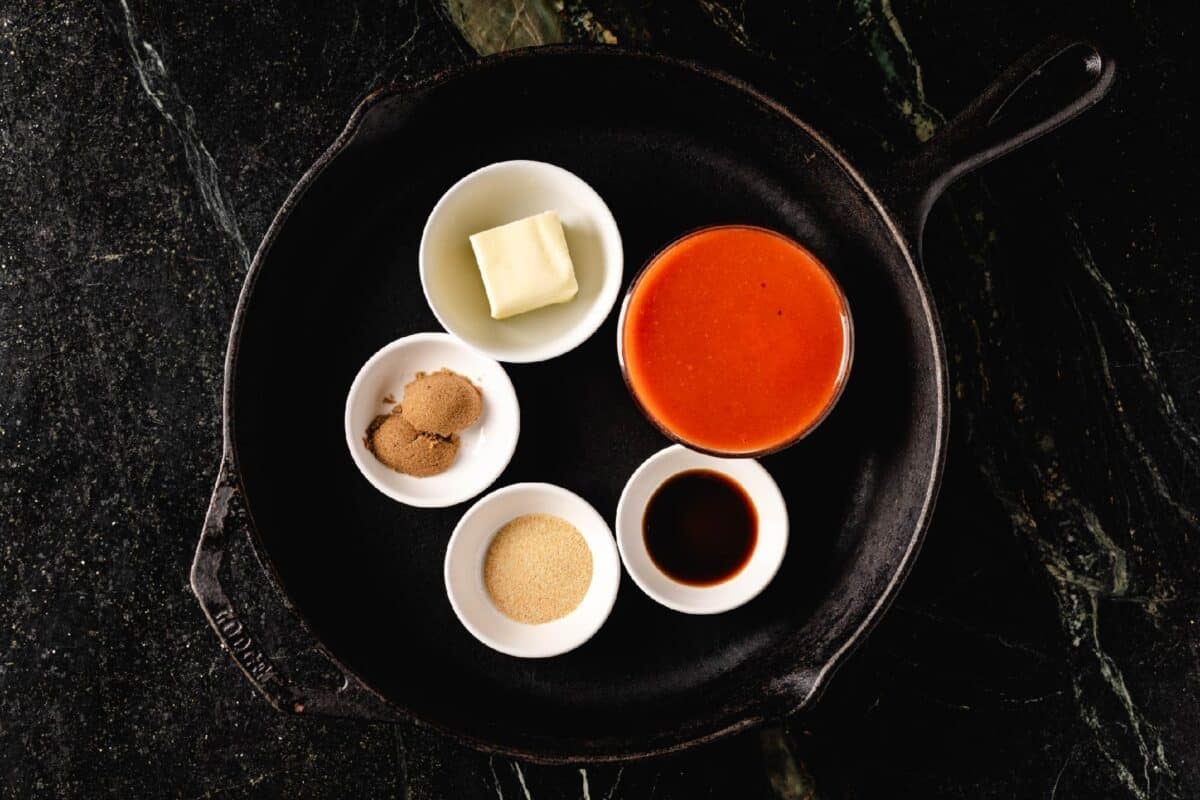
left=617, top=222, right=854, bottom=458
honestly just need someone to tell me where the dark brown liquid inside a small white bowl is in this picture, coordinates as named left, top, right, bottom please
left=642, top=469, right=758, bottom=587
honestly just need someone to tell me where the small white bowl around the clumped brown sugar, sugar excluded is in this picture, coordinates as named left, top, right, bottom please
left=346, top=333, right=521, bottom=509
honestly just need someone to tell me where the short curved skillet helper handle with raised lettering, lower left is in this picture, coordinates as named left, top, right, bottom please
left=191, top=449, right=400, bottom=721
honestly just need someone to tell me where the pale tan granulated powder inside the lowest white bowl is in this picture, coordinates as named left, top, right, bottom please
left=484, top=513, right=592, bottom=625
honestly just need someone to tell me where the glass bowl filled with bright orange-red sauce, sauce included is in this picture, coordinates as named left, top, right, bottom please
left=618, top=225, right=854, bottom=456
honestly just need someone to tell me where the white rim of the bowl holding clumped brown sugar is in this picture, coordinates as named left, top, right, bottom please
left=342, top=331, right=521, bottom=509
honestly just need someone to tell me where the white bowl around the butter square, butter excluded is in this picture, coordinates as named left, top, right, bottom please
left=419, top=161, right=624, bottom=362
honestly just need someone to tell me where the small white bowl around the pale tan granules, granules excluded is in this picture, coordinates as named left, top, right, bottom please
left=445, top=483, right=620, bottom=658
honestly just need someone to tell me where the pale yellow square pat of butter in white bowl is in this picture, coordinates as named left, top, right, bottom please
left=470, top=211, right=580, bottom=319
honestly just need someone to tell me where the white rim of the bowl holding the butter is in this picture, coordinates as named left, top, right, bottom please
left=416, top=158, right=625, bottom=363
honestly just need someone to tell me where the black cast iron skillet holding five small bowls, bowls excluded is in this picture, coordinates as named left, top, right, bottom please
left=192, top=41, right=1114, bottom=762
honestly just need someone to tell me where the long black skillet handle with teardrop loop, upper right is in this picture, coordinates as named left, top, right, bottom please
left=883, top=36, right=1116, bottom=253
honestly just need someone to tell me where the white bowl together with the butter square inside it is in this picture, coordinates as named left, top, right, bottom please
left=419, top=161, right=624, bottom=362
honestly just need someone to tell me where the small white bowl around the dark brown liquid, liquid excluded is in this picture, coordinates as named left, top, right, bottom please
left=617, top=445, right=787, bottom=614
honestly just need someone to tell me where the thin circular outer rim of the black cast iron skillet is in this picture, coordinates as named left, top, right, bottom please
left=221, top=44, right=949, bottom=764
